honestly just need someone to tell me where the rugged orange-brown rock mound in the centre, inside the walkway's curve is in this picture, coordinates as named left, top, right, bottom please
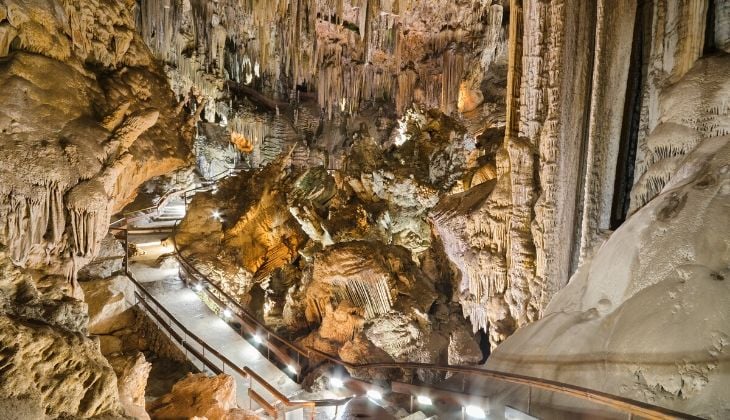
left=175, top=117, right=483, bottom=380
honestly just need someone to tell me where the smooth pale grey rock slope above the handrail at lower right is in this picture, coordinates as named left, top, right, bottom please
left=487, top=136, right=730, bottom=419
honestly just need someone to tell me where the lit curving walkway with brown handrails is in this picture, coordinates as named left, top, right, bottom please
left=112, top=184, right=694, bottom=419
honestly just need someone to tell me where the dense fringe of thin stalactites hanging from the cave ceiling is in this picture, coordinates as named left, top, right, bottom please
left=139, top=0, right=504, bottom=127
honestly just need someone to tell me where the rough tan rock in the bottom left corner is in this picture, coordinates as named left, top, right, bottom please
left=0, top=251, right=121, bottom=418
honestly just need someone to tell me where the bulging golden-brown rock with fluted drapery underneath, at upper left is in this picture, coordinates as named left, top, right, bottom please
left=0, top=0, right=188, bottom=277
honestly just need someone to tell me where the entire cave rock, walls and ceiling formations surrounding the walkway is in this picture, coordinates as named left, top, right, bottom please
left=0, top=0, right=730, bottom=419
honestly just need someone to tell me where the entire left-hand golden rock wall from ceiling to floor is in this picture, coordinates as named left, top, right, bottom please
left=0, top=0, right=192, bottom=419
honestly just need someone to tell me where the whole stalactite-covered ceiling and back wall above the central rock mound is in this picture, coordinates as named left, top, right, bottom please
left=139, top=0, right=506, bottom=168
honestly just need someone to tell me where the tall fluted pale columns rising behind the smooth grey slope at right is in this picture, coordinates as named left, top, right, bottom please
left=432, top=0, right=727, bottom=352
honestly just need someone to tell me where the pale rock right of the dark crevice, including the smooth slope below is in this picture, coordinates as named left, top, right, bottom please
left=484, top=2, right=730, bottom=419
